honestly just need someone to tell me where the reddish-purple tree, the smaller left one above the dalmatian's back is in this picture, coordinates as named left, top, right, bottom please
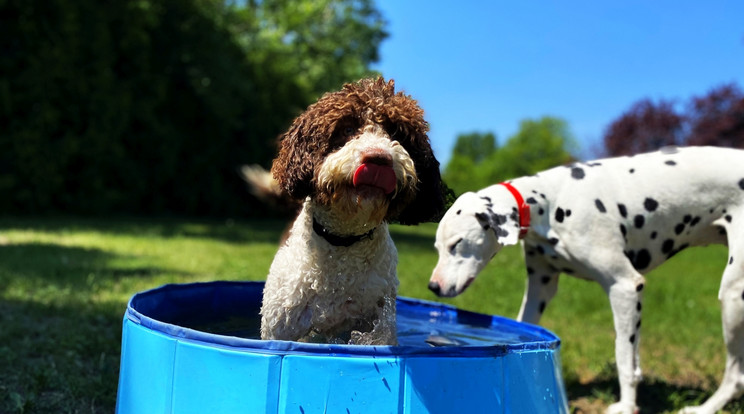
left=604, top=99, right=684, bottom=156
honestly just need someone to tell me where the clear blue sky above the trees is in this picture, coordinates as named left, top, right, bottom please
left=373, top=0, right=744, bottom=164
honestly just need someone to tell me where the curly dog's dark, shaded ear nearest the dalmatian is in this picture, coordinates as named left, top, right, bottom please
left=395, top=135, right=447, bottom=225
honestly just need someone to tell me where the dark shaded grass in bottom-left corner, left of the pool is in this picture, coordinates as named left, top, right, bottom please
left=0, top=300, right=123, bottom=413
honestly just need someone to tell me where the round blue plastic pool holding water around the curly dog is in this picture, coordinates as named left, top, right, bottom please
left=116, top=282, right=568, bottom=414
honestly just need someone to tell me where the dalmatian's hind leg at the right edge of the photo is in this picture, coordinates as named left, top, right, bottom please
left=681, top=214, right=744, bottom=413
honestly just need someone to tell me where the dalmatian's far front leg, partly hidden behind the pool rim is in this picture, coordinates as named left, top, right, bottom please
left=517, top=249, right=560, bottom=324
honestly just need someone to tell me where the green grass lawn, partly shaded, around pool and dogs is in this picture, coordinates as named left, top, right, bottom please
left=0, top=218, right=744, bottom=413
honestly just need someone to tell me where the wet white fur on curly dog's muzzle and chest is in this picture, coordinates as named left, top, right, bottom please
left=261, top=127, right=416, bottom=344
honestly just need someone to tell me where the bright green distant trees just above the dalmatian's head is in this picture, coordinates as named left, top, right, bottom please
left=443, top=116, right=576, bottom=195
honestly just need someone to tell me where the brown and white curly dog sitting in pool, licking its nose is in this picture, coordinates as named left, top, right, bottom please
left=261, top=78, right=444, bottom=344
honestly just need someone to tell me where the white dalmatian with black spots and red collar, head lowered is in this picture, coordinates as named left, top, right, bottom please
left=429, top=147, right=744, bottom=413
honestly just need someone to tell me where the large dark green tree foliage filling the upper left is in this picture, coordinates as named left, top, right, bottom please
left=0, top=0, right=386, bottom=215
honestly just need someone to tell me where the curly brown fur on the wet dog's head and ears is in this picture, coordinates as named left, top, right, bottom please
left=272, top=78, right=444, bottom=224
